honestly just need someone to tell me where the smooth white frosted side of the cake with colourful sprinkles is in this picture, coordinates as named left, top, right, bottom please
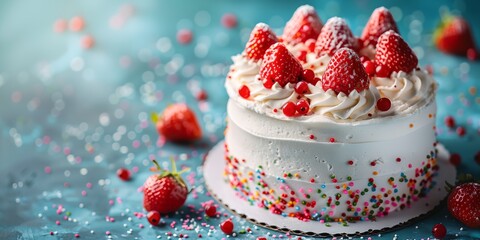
left=225, top=98, right=437, bottom=221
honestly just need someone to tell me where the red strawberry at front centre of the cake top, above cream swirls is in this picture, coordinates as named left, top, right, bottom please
left=322, top=48, right=370, bottom=95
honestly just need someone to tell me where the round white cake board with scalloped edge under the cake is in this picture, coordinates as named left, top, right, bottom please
left=203, top=141, right=457, bottom=237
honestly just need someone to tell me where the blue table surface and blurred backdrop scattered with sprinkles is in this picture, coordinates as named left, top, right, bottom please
left=0, top=0, right=480, bottom=239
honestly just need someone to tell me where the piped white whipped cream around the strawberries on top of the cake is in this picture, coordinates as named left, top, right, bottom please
left=225, top=52, right=436, bottom=122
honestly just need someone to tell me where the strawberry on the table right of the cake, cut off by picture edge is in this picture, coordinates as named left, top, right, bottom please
left=447, top=182, right=480, bottom=228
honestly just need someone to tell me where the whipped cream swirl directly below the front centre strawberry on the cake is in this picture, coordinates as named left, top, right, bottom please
left=305, top=83, right=380, bottom=120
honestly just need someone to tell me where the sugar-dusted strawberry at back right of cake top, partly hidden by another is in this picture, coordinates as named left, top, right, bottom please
left=360, top=7, right=398, bottom=47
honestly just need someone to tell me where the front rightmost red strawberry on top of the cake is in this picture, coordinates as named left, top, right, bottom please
left=375, top=30, right=418, bottom=75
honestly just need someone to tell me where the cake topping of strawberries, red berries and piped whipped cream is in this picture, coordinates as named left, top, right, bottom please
left=225, top=5, right=436, bottom=122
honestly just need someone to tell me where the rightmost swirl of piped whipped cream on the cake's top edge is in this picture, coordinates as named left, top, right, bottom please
left=371, top=70, right=436, bottom=113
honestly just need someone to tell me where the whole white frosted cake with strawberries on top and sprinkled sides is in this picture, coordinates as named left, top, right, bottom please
left=224, top=5, right=439, bottom=223
